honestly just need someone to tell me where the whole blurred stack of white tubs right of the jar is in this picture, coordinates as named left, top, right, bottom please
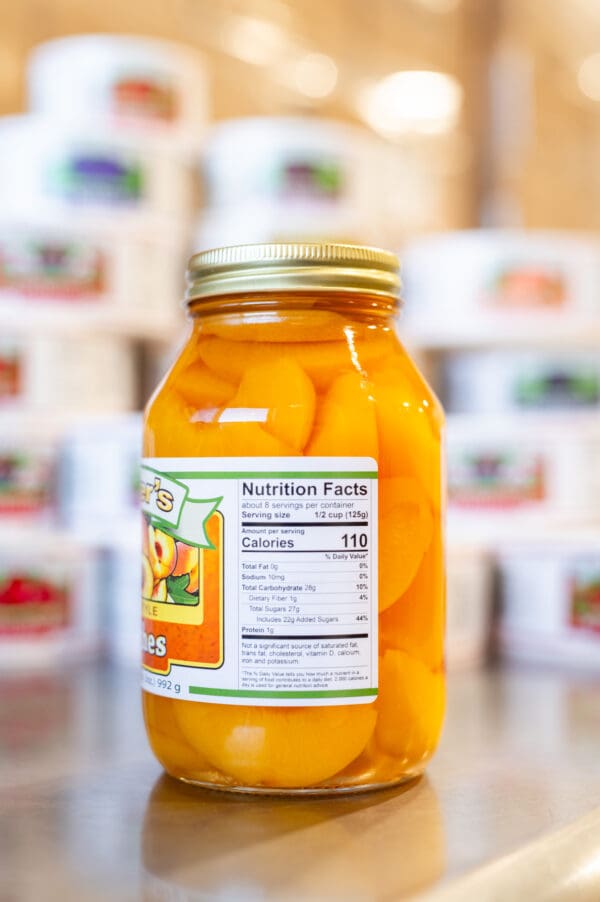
left=404, top=230, right=600, bottom=666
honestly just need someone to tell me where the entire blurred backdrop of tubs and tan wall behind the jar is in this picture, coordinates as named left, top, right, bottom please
left=0, top=0, right=600, bottom=691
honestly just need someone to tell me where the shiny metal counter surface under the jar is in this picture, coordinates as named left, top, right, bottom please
left=0, top=669, right=600, bottom=902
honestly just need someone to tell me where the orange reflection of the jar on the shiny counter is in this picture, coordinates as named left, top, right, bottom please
left=142, top=776, right=446, bottom=902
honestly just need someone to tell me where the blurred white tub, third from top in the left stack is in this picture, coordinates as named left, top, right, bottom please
left=0, top=217, right=187, bottom=317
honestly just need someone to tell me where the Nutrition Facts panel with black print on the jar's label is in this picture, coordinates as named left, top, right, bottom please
left=239, top=461, right=377, bottom=701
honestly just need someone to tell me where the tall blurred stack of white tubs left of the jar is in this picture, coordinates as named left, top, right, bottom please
left=0, top=35, right=207, bottom=665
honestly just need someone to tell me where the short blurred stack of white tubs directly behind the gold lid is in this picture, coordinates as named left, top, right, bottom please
left=196, top=117, right=382, bottom=250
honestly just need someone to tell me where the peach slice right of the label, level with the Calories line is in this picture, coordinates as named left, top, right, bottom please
left=379, top=477, right=434, bottom=611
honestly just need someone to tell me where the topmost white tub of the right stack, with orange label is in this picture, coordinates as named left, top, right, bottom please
left=402, top=229, right=600, bottom=328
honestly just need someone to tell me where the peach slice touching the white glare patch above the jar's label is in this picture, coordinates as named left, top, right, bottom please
left=229, top=357, right=315, bottom=453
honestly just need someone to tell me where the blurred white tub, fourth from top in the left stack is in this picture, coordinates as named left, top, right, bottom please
left=0, top=333, right=136, bottom=415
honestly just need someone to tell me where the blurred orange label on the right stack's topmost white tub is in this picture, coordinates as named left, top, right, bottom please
left=485, top=263, right=567, bottom=308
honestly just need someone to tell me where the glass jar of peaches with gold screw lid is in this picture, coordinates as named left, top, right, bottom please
left=142, top=244, right=445, bottom=793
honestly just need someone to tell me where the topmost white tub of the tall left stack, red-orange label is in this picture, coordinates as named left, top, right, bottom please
left=28, top=34, right=208, bottom=143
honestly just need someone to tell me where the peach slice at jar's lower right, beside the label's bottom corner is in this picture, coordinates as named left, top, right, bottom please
left=375, top=651, right=445, bottom=765
